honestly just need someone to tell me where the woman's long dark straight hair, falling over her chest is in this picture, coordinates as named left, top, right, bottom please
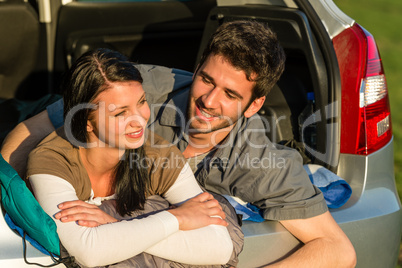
left=61, top=48, right=150, bottom=216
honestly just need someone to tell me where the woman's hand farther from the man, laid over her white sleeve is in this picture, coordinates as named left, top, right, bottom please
left=54, top=200, right=117, bottom=227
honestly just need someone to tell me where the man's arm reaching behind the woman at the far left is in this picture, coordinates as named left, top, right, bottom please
left=0, top=110, right=54, bottom=178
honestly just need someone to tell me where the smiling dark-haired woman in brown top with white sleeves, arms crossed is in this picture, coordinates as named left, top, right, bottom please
left=27, top=49, right=233, bottom=266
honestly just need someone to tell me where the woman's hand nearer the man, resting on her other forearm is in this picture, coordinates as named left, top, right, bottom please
left=169, top=192, right=228, bottom=230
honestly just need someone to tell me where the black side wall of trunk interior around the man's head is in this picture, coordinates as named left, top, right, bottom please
left=198, top=5, right=340, bottom=171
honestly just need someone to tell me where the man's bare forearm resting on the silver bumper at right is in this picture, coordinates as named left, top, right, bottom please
left=267, top=211, right=356, bottom=268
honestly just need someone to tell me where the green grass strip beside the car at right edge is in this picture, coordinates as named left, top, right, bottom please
left=334, top=0, right=402, bottom=268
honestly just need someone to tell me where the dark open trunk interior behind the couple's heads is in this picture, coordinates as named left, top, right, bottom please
left=48, top=0, right=340, bottom=171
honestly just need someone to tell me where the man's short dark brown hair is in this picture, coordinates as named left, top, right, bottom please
left=198, top=20, right=286, bottom=101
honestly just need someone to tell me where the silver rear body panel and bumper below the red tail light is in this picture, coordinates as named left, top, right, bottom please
left=239, top=141, right=402, bottom=268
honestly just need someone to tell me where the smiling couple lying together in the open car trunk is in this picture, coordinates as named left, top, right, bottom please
left=2, top=21, right=355, bottom=267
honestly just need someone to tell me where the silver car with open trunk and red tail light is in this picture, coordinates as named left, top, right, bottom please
left=0, top=0, right=402, bottom=267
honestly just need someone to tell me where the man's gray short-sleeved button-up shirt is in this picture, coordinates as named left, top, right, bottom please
left=47, top=65, right=328, bottom=220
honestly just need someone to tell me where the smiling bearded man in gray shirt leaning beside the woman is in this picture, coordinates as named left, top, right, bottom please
left=2, top=21, right=356, bottom=267
